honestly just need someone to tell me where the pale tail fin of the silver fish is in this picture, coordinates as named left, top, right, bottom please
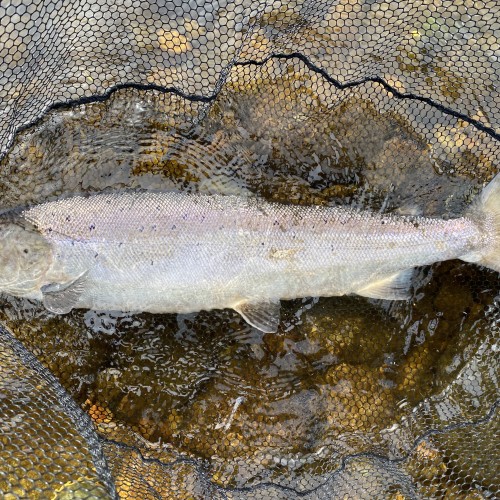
left=467, top=174, right=500, bottom=272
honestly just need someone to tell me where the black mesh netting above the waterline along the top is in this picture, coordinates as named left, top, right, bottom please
left=0, top=0, right=499, bottom=164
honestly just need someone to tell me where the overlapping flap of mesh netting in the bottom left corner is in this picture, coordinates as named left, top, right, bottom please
left=0, top=328, right=114, bottom=498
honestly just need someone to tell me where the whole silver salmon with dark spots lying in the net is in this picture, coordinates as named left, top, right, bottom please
left=0, top=174, right=500, bottom=332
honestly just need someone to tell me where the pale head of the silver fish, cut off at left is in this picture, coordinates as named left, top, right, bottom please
left=0, top=220, right=52, bottom=296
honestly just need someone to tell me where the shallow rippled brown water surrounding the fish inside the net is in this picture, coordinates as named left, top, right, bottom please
left=0, top=84, right=498, bottom=491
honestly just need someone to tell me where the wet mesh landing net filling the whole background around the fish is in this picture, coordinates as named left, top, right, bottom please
left=0, top=0, right=500, bottom=499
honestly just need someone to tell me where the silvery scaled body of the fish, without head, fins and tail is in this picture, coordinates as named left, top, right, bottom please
left=19, top=193, right=480, bottom=312
